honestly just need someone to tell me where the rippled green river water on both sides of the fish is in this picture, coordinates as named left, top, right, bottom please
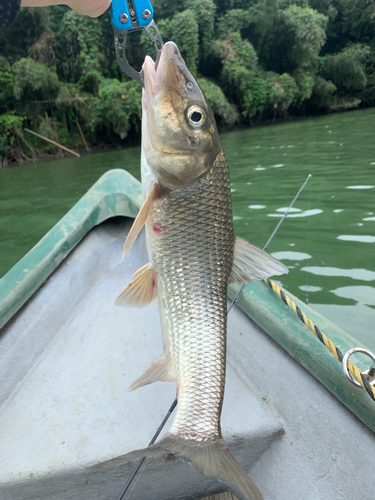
left=0, top=109, right=375, bottom=350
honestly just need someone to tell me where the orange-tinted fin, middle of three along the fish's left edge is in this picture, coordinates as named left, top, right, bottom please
left=115, top=263, right=156, bottom=307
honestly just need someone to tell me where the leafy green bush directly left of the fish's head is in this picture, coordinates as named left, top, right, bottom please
left=89, top=78, right=142, bottom=139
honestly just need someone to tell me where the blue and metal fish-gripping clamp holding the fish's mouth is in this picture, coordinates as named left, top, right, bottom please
left=111, top=0, right=163, bottom=86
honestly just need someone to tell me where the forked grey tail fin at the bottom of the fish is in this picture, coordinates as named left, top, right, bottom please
left=97, top=433, right=263, bottom=500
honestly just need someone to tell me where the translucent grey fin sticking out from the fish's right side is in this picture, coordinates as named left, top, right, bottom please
left=228, top=236, right=289, bottom=285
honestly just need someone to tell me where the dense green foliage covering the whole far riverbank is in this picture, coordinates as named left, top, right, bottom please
left=0, top=0, right=375, bottom=162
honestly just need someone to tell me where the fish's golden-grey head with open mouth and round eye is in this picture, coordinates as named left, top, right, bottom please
left=142, top=42, right=221, bottom=189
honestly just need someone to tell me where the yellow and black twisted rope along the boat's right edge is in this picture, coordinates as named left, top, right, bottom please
left=264, top=278, right=375, bottom=401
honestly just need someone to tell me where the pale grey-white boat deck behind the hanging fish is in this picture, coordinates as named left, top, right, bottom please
left=0, top=218, right=375, bottom=500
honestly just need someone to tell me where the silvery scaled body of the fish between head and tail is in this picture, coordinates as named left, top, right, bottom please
left=149, top=153, right=234, bottom=441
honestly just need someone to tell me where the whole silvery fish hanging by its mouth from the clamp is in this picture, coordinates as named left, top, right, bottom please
left=111, top=42, right=288, bottom=500
